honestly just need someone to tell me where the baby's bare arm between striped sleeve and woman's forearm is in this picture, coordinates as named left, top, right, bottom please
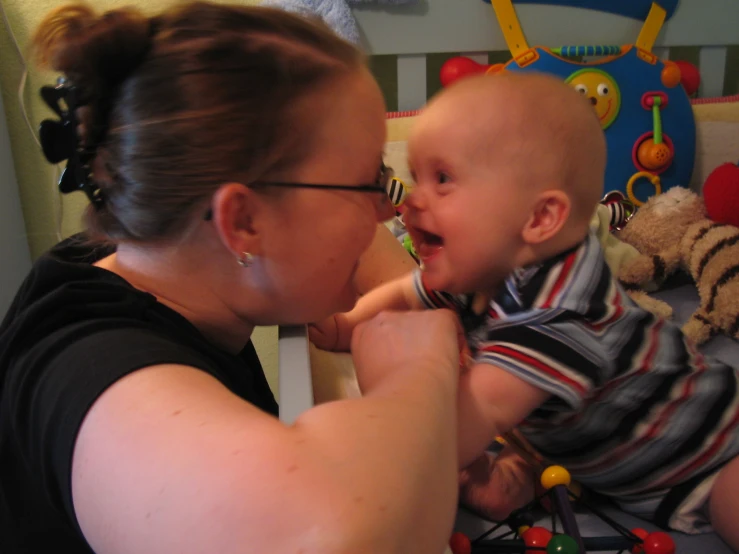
left=458, top=363, right=550, bottom=468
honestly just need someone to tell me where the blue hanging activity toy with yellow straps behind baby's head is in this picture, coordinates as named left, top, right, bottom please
left=440, top=0, right=695, bottom=206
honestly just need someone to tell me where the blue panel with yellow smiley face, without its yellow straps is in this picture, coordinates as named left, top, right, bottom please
left=505, top=47, right=695, bottom=201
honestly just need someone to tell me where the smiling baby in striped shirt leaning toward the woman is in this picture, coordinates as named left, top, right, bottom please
left=311, top=73, right=739, bottom=549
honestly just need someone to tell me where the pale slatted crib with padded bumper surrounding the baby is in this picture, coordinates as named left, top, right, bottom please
left=279, top=0, right=739, bottom=554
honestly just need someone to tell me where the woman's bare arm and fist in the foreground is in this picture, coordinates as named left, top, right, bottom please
left=72, top=310, right=458, bottom=554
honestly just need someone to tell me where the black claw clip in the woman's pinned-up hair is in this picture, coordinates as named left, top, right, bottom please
left=39, top=79, right=103, bottom=207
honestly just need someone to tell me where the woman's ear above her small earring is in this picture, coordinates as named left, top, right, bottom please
left=211, top=183, right=261, bottom=257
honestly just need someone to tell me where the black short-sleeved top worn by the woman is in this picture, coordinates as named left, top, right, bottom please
left=0, top=235, right=277, bottom=554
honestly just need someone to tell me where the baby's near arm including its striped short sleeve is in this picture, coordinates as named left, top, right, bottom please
left=458, top=310, right=600, bottom=466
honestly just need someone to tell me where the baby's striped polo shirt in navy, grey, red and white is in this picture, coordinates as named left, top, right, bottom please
left=415, top=235, right=739, bottom=522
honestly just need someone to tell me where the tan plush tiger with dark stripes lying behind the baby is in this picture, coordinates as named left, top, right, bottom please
left=618, top=187, right=739, bottom=344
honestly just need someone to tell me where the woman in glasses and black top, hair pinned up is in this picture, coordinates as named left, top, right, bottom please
left=0, top=3, right=458, bottom=554
